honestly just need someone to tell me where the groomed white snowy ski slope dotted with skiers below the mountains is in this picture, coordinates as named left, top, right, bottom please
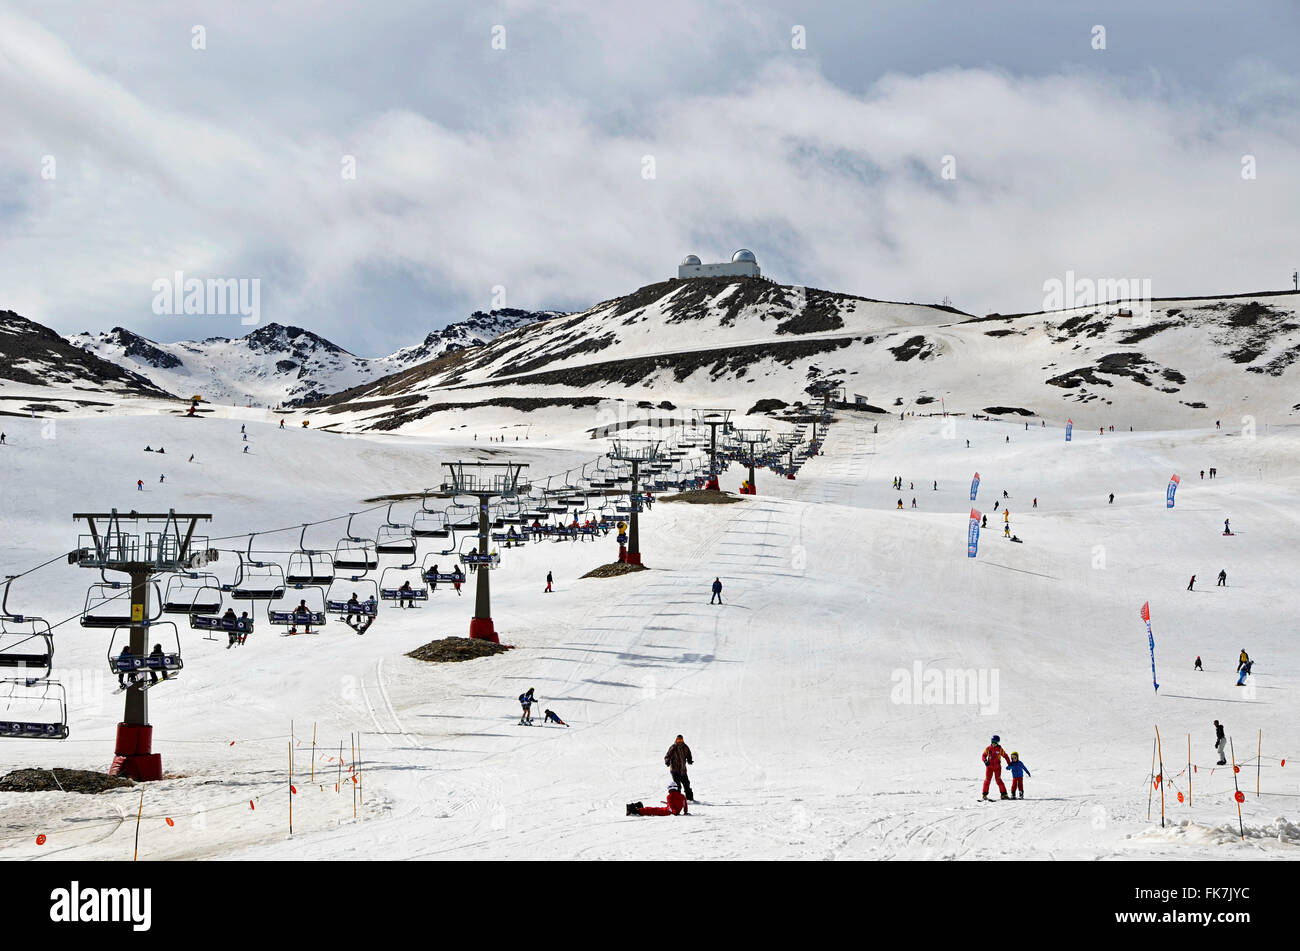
left=0, top=409, right=1300, bottom=860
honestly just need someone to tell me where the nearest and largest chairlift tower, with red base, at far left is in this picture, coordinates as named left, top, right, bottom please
left=68, top=508, right=217, bottom=782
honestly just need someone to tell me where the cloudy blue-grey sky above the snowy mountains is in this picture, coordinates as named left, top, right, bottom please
left=0, top=0, right=1300, bottom=356
